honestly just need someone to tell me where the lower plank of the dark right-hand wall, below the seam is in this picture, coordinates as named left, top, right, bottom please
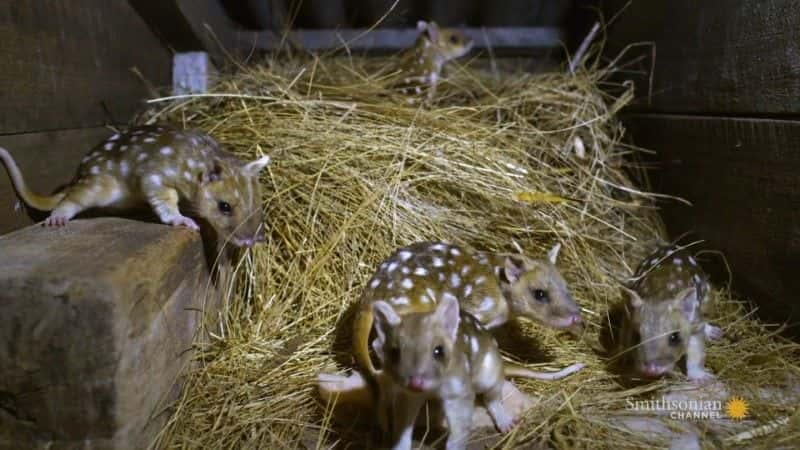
left=625, top=114, right=800, bottom=335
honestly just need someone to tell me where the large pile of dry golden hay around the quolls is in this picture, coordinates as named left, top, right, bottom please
left=147, top=51, right=800, bottom=448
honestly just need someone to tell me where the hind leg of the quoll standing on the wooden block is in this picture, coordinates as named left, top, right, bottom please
left=42, top=175, right=124, bottom=227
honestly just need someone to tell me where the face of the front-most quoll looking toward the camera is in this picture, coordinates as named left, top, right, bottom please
left=373, top=298, right=459, bottom=392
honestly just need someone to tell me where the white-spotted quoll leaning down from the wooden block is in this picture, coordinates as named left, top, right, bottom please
left=0, top=126, right=270, bottom=247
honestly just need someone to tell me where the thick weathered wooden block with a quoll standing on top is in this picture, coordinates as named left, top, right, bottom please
left=0, top=218, right=219, bottom=449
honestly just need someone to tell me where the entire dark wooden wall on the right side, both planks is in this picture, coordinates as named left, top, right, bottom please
left=604, top=0, right=800, bottom=335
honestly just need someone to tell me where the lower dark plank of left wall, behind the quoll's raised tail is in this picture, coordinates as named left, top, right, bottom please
left=0, top=127, right=112, bottom=235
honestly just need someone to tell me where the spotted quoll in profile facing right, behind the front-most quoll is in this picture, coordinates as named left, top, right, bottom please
left=353, top=242, right=583, bottom=379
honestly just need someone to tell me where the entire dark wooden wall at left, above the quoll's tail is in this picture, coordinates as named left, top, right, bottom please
left=0, top=0, right=172, bottom=234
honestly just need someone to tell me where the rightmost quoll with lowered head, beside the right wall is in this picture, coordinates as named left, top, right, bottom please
left=624, top=246, right=722, bottom=381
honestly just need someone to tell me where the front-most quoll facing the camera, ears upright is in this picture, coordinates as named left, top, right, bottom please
left=372, top=294, right=515, bottom=449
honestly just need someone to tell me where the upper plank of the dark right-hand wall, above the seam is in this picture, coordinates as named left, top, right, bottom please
left=606, top=0, right=800, bottom=116
